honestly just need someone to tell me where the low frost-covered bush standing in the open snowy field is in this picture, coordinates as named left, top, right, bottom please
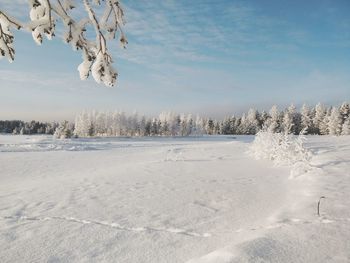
left=249, top=130, right=312, bottom=177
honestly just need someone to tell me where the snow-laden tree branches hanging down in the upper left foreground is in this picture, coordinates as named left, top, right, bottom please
left=0, top=0, right=127, bottom=86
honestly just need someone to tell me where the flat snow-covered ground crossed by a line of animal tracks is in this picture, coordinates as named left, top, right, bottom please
left=0, top=135, right=350, bottom=263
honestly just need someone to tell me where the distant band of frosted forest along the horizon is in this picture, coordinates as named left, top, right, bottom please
left=0, top=102, right=350, bottom=138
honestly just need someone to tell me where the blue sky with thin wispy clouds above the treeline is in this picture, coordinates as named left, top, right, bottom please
left=0, top=0, right=350, bottom=120
